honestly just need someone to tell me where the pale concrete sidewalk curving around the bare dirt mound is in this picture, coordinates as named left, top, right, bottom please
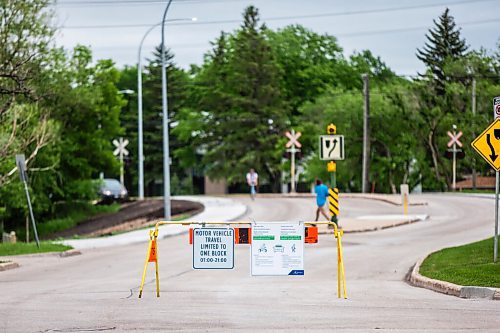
left=61, top=196, right=247, bottom=249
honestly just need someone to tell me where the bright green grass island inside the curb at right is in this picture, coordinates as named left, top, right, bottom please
left=420, top=238, right=500, bottom=288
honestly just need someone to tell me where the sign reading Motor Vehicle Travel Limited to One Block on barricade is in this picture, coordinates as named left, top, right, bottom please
left=193, top=228, right=234, bottom=269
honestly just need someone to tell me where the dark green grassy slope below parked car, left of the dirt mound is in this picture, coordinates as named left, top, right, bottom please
left=25, top=203, right=120, bottom=239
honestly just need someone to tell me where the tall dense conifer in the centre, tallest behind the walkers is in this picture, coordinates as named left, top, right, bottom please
left=184, top=6, right=288, bottom=191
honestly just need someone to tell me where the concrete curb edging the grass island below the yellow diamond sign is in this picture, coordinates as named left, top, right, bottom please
left=408, top=252, right=500, bottom=300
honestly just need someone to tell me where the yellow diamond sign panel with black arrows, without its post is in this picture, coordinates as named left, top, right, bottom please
left=471, top=118, right=500, bottom=171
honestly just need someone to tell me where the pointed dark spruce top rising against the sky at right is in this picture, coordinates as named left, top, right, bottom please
left=417, top=8, right=467, bottom=96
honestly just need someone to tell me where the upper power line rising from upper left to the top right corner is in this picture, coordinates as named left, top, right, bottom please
left=61, top=0, right=495, bottom=29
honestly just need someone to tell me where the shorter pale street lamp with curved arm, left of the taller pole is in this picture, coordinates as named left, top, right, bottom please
left=137, top=15, right=196, bottom=200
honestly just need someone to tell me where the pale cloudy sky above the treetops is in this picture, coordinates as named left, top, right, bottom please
left=53, top=0, right=500, bottom=75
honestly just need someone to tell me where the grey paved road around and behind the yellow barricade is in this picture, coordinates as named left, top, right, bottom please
left=0, top=195, right=500, bottom=333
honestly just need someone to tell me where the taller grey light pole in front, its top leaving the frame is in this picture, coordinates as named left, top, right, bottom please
left=161, top=0, right=172, bottom=221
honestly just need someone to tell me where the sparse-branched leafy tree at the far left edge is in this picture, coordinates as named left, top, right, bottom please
left=0, top=0, right=55, bottom=186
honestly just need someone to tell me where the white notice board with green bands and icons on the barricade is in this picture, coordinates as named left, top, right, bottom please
left=251, top=222, right=304, bottom=275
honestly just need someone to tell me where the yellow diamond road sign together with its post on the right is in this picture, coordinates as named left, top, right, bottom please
left=471, top=116, right=500, bottom=262
